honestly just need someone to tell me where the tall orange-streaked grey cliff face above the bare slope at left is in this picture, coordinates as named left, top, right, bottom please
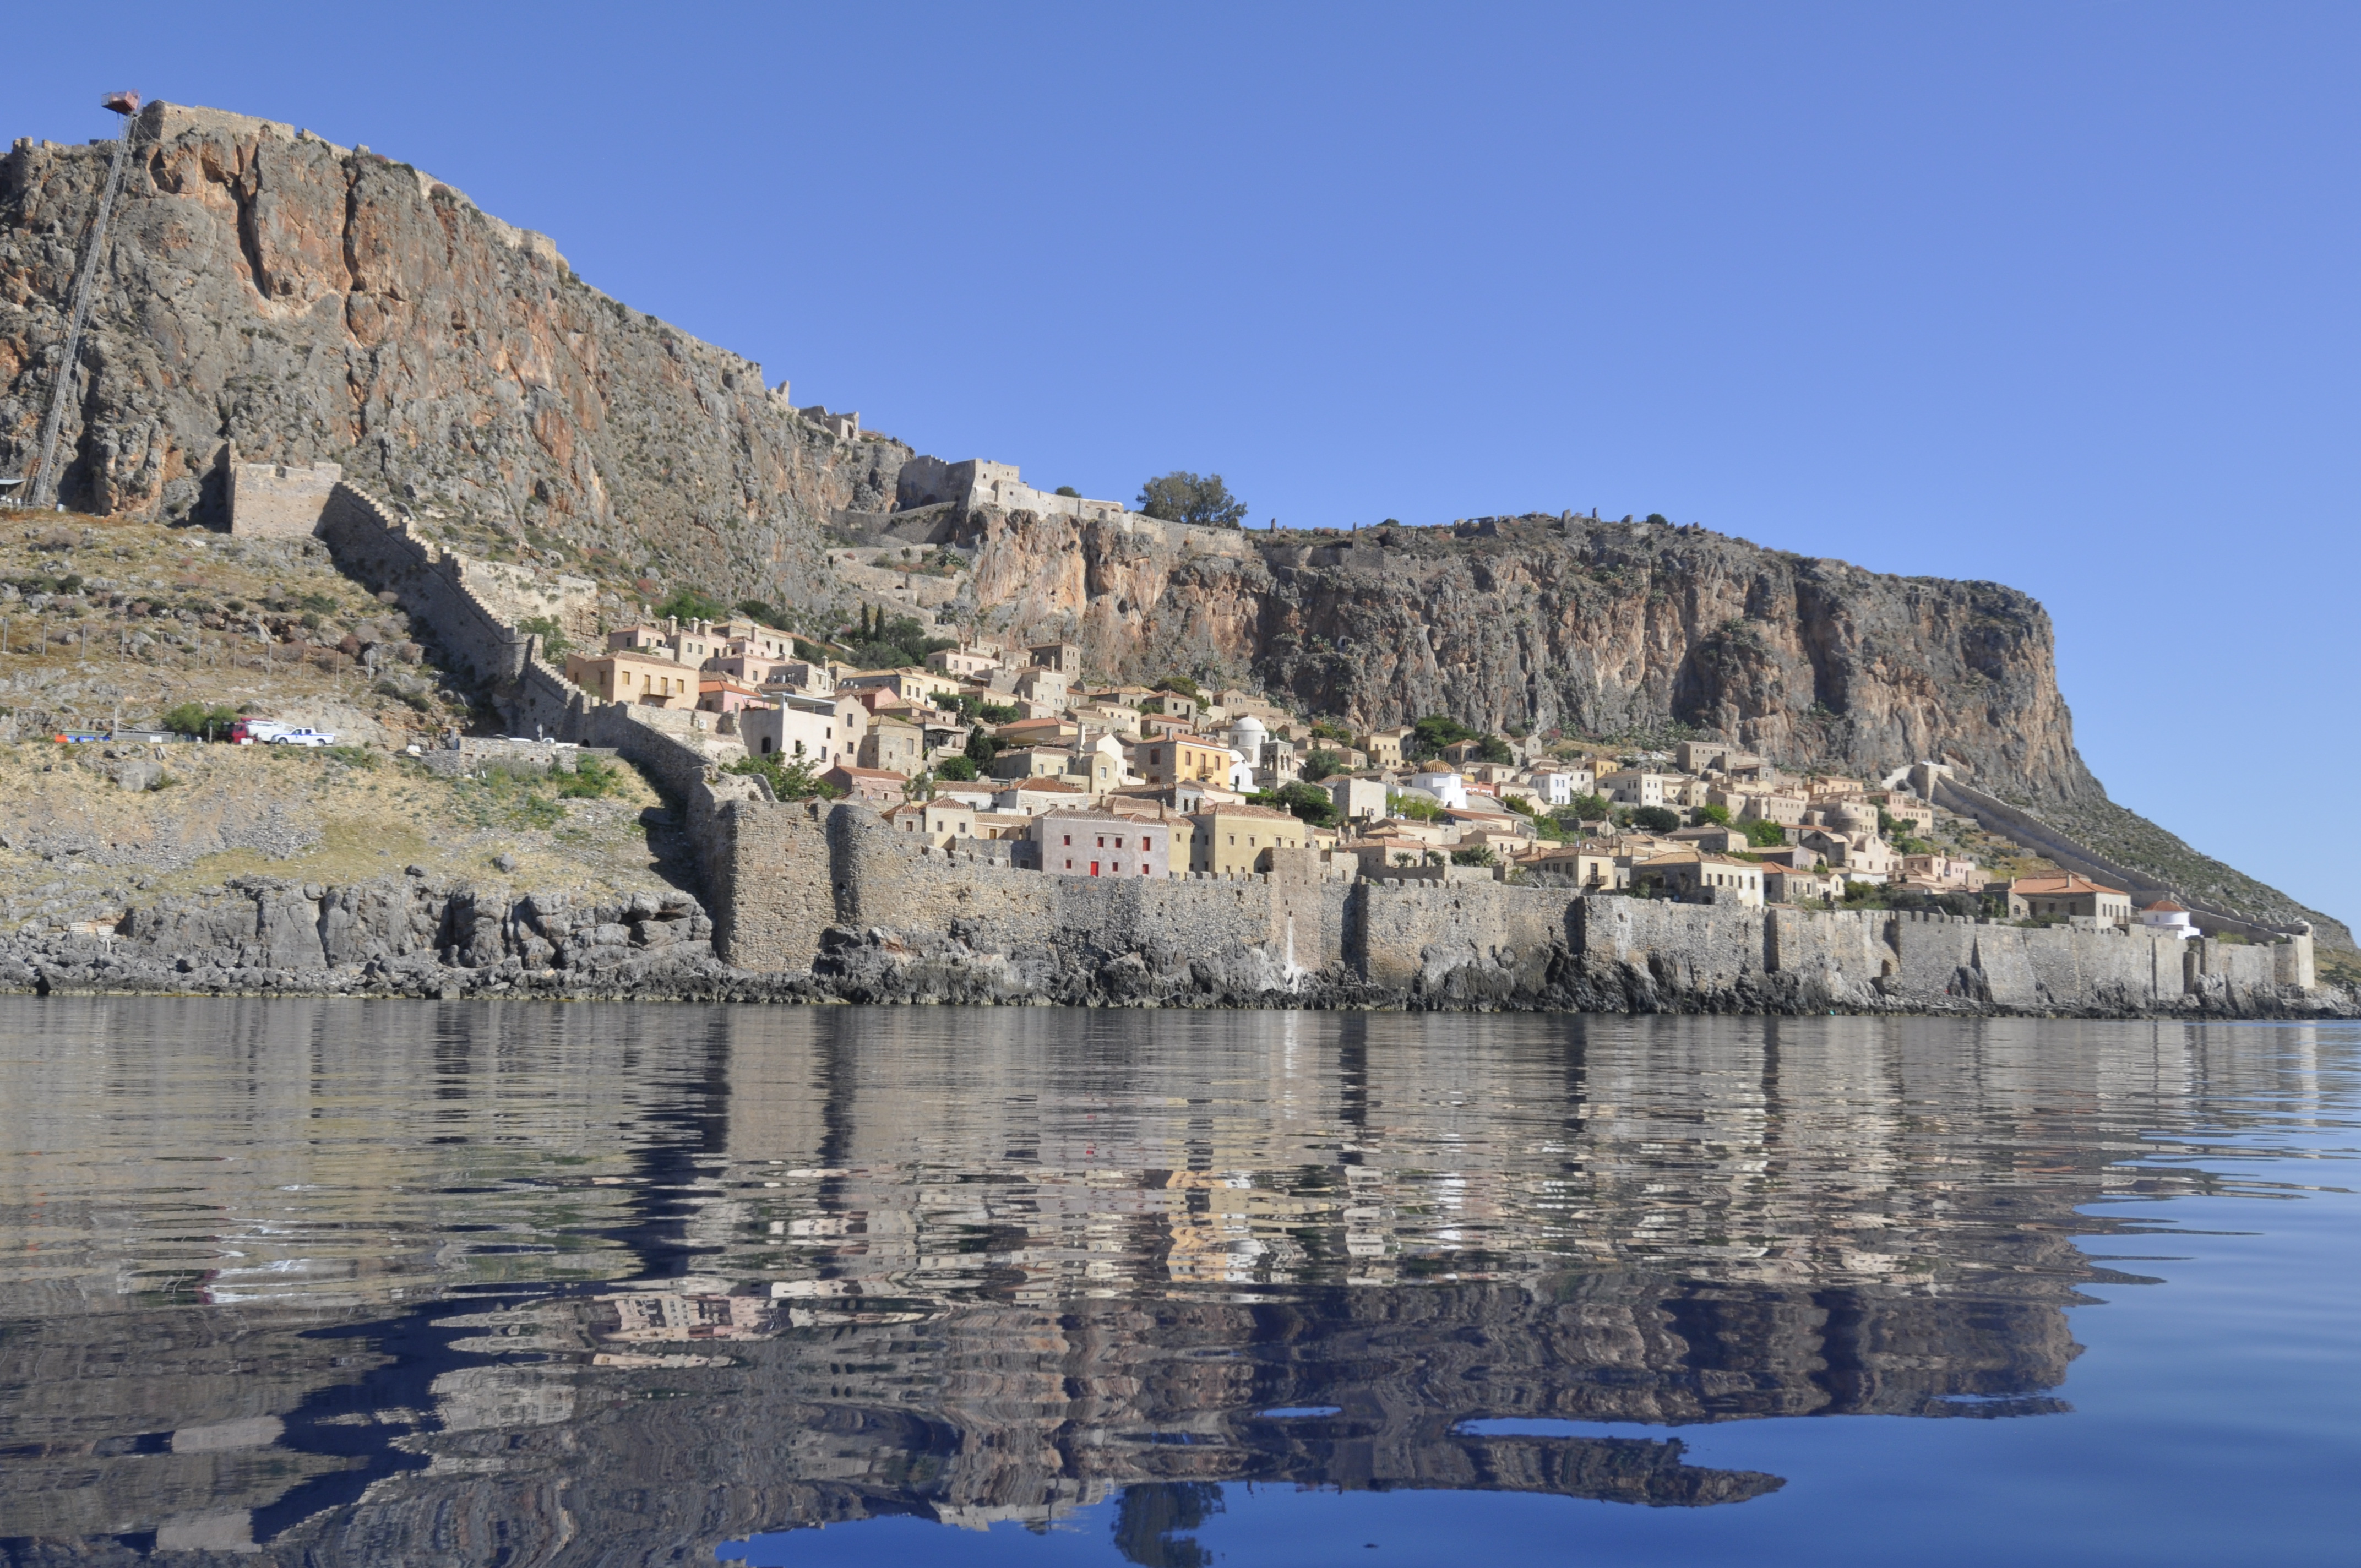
left=0, top=104, right=907, bottom=600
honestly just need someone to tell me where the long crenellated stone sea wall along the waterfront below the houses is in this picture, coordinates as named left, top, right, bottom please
left=706, top=798, right=2316, bottom=1015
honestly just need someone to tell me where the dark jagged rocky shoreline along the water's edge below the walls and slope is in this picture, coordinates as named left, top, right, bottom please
left=0, top=867, right=2361, bottom=1020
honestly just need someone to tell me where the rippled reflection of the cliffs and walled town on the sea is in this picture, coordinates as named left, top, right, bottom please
left=0, top=1001, right=2319, bottom=1563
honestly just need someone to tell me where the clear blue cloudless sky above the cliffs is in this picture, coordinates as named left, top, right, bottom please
left=18, top=5, right=2361, bottom=918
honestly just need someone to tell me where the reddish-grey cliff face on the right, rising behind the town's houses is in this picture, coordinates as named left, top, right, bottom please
left=949, top=513, right=2097, bottom=801
